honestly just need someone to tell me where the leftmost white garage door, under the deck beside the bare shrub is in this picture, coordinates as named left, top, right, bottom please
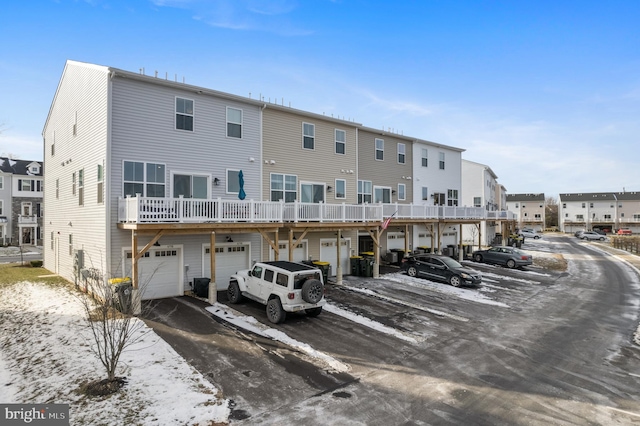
left=125, top=247, right=184, bottom=300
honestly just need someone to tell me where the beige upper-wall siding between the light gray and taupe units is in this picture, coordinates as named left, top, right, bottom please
left=262, top=106, right=358, bottom=204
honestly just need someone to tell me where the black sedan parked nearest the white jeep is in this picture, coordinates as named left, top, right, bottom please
left=401, top=254, right=482, bottom=287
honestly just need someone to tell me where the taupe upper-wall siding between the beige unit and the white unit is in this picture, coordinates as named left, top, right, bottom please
left=358, top=129, right=413, bottom=203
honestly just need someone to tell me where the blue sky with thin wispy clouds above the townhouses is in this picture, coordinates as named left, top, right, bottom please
left=0, top=0, right=640, bottom=197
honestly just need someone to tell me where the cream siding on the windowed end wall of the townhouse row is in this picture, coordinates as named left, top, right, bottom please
left=43, top=62, right=109, bottom=281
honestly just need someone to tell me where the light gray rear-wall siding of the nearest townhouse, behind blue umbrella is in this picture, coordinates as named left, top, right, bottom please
left=110, top=77, right=262, bottom=267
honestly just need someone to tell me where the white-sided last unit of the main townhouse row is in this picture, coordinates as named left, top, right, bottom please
left=412, top=140, right=464, bottom=251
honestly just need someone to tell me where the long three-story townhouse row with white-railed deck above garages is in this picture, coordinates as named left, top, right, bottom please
left=43, top=61, right=510, bottom=299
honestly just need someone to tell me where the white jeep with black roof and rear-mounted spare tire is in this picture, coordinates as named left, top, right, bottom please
left=227, top=261, right=326, bottom=324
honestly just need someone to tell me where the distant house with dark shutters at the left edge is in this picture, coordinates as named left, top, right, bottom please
left=0, top=157, right=44, bottom=245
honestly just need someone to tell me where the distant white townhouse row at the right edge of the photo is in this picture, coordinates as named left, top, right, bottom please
left=558, top=191, right=640, bottom=234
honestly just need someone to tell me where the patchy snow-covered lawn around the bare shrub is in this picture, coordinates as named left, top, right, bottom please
left=0, top=282, right=230, bottom=425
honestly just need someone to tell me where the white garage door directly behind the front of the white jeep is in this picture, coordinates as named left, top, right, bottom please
left=202, top=243, right=251, bottom=290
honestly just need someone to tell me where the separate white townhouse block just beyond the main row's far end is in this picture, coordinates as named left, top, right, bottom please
left=462, top=160, right=506, bottom=246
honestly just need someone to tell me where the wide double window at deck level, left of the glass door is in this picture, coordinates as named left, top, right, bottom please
left=123, top=161, right=166, bottom=197
